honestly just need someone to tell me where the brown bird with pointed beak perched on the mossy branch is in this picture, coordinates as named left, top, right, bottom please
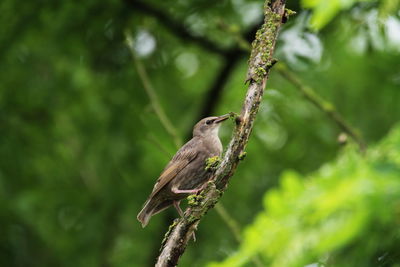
left=137, top=114, right=229, bottom=227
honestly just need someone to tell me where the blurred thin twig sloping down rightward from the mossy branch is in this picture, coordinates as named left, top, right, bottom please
left=277, top=64, right=366, bottom=152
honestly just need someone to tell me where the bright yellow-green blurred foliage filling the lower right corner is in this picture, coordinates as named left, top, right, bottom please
left=208, top=126, right=400, bottom=267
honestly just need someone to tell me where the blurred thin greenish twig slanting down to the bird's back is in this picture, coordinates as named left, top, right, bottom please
left=126, top=33, right=182, bottom=148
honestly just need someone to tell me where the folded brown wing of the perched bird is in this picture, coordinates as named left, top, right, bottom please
left=149, top=139, right=199, bottom=199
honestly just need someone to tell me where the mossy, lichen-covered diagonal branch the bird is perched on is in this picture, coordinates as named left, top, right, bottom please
left=156, top=0, right=285, bottom=267
